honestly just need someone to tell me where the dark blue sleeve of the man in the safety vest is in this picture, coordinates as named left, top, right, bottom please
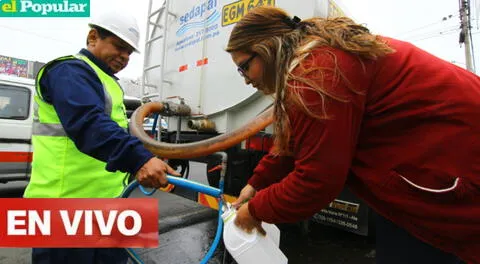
left=40, top=60, right=153, bottom=174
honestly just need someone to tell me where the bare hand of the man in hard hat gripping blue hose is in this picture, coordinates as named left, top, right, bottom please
left=135, top=157, right=180, bottom=189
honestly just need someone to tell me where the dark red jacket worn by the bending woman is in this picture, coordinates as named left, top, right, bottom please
left=249, top=38, right=480, bottom=263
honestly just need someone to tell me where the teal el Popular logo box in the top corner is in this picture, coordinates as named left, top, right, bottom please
left=0, top=0, right=90, bottom=17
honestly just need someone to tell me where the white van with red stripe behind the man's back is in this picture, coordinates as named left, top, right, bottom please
left=0, top=75, right=35, bottom=183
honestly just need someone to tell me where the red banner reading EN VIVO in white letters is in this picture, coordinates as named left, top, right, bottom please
left=0, top=198, right=158, bottom=248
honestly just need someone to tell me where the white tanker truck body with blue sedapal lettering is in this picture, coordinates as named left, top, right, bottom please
left=144, top=0, right=344, bottom=133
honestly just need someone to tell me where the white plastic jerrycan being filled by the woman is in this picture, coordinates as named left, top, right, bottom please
left=222, top=204, right=288, bottom=264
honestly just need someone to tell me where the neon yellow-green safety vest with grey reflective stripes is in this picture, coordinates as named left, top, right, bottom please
left=24, top=55, right=128, bottom=198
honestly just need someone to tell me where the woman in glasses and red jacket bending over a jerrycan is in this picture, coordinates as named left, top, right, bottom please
left=227, top=7, right=480, bottom=263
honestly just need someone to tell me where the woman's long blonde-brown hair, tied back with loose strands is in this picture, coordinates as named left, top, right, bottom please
left=226, top=7, right=394, bottom=154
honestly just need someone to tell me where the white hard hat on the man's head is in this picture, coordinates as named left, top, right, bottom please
left=88, top=12, right=140, bottom=52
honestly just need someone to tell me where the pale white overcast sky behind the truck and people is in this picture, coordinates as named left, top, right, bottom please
left=0, top=0, right=480, bottom=79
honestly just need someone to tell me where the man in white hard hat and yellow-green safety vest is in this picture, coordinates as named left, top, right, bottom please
left=24, top=12, right=178, bottom=263
